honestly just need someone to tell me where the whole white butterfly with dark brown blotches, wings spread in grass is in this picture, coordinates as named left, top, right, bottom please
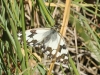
left=18, top=28, right=68, bottom=62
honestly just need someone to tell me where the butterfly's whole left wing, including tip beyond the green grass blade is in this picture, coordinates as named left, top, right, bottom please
left=18, top=28, right=50, bottom=46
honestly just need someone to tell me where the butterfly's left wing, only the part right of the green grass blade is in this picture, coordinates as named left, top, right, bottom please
left=26, top=28, right=50, bottom=43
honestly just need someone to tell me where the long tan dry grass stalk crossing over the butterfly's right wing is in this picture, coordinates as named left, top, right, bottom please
left=47, top=0, right=71, bottom=75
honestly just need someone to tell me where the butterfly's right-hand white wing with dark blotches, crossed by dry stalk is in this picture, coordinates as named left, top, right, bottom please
left=44, top=31, right=68, bottom=61
